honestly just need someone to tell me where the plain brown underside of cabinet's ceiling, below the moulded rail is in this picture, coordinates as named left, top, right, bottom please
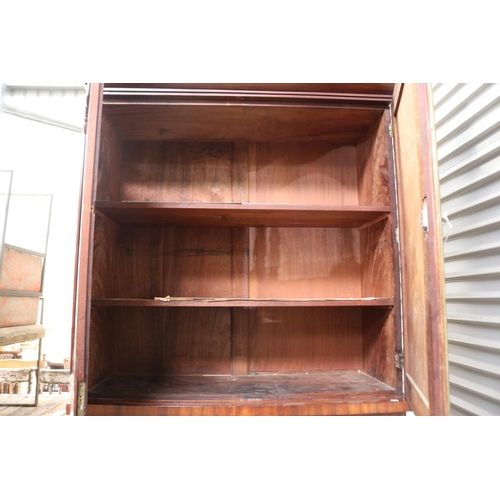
left=105, top=103, right=383, bottom=145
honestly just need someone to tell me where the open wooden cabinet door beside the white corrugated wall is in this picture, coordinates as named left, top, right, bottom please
left=393, top=84, right=449, bottom=415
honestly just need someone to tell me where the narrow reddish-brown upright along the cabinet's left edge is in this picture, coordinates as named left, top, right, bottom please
left=70, top=83, right=102, bottom=415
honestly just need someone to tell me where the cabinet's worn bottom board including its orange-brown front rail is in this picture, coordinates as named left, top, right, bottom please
left=88, top=371, right=408, bottom=415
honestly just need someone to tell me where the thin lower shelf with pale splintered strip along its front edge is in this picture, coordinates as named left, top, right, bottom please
left=92, top=297, right=394, bottom=308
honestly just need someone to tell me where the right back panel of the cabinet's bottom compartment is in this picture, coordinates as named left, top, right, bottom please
left=250, top=307, right=362, bottom=373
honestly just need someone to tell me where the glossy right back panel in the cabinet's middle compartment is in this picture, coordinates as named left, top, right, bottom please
left=250, top=228, right=362, bottom=298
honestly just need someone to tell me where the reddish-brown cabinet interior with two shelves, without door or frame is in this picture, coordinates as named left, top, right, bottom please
left=88, top=101, right=402, bottom=412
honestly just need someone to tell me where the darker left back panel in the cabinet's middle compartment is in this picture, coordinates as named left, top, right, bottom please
left=108, top=226, right=248, bottom=299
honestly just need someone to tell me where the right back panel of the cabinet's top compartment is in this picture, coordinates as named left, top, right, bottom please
left=249, top=143, right=358, bottom=205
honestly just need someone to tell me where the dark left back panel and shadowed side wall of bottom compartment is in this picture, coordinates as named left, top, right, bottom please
left=89, top=307, right=231, bottom=376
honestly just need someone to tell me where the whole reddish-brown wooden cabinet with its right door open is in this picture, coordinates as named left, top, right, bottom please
left=73, top=84, right=448, bottom=415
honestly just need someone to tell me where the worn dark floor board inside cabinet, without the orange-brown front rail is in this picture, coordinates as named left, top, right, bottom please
left=89, top=371, right=404, bottom=411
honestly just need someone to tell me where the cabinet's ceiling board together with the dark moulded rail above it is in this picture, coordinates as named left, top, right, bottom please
left=103, top=83, right=394, bottom=144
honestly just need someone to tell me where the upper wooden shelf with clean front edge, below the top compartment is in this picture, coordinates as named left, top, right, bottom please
left=95, top=201, right=390, bottom=228
